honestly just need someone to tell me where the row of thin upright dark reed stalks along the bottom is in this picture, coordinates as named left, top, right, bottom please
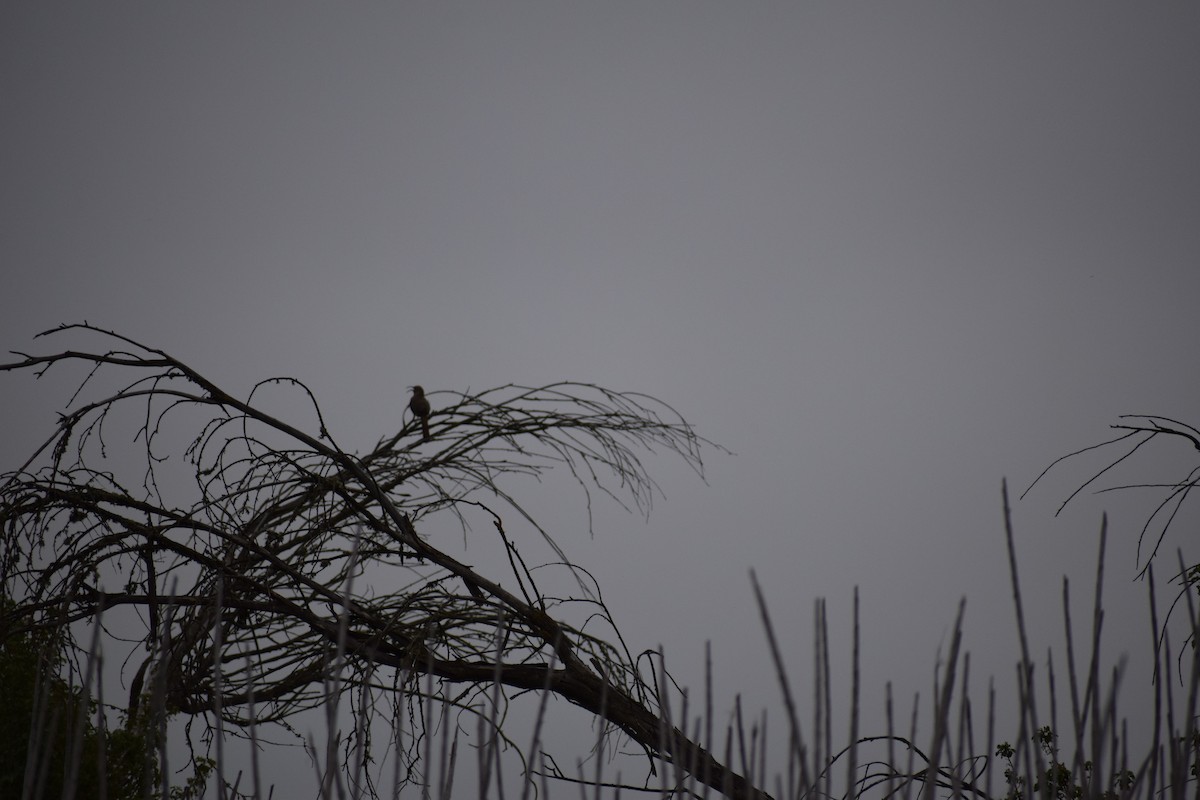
left=6, top=491, right=1200, bottom=800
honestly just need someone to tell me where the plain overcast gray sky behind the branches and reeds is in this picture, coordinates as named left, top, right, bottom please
left=0, top=2, right=1200, bottom=796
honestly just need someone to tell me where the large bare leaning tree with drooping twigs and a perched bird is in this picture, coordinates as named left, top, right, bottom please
left=0, top=324, right=766, bottom=798
